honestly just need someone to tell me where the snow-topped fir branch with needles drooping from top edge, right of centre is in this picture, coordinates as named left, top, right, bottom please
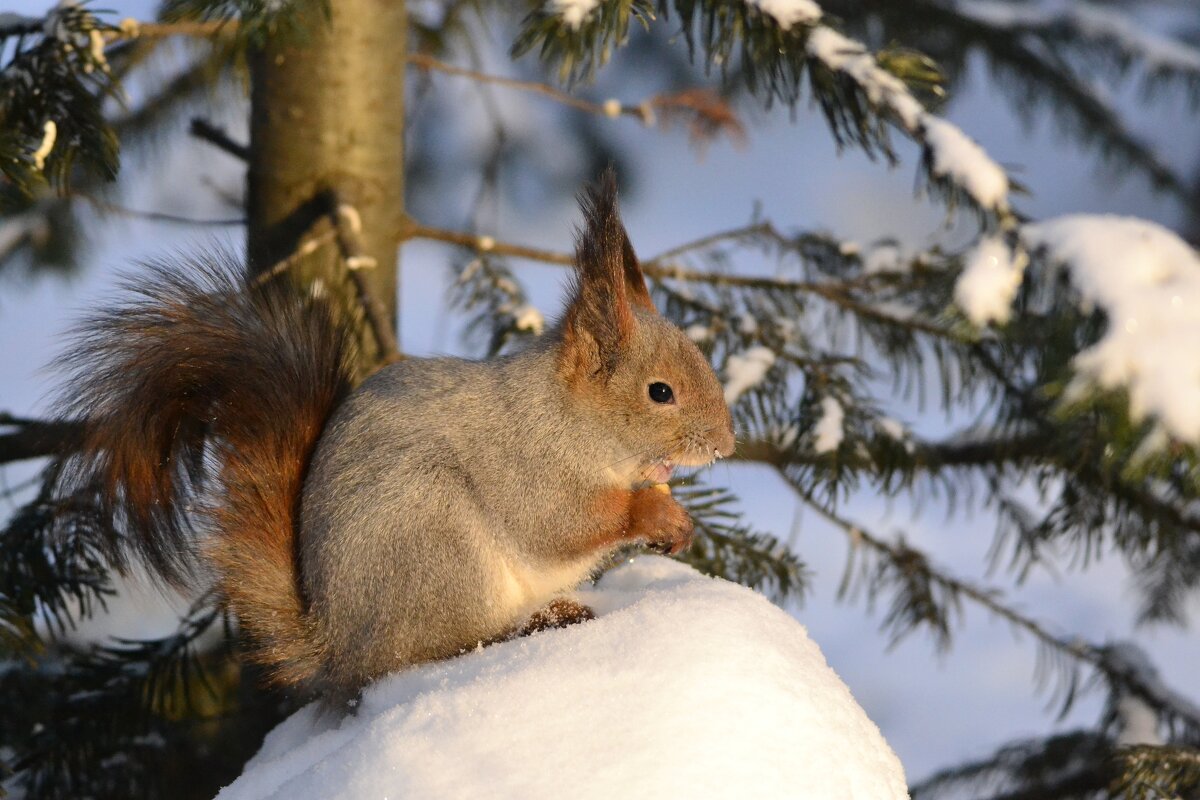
left=512, top=0, right=1012, bottom=219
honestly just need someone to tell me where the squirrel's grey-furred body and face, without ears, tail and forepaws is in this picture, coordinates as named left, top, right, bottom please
left=301, top=312, right=732, bottom=690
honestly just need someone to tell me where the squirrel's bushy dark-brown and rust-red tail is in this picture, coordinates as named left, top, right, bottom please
left=59, top=255, right=353, bottom=685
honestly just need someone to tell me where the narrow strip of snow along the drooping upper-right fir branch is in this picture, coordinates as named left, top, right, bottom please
left=808, top=26, right=1009, bottom=211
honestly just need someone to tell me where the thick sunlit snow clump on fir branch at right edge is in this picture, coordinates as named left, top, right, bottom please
left=1021, top=215, right=1200, bottom=443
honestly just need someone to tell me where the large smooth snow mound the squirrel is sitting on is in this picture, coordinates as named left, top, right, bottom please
left=218, top=557, right=908, bottom=800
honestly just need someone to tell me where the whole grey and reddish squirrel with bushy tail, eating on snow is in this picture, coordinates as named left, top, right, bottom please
left=51, top=169, right=734, bottom=699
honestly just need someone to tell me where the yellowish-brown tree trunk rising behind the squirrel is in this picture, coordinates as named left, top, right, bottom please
left=246, top=0, right=408, bottom=356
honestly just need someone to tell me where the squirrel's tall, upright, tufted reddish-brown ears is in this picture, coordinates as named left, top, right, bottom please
left=563, top=167, right=653, bottom=378
